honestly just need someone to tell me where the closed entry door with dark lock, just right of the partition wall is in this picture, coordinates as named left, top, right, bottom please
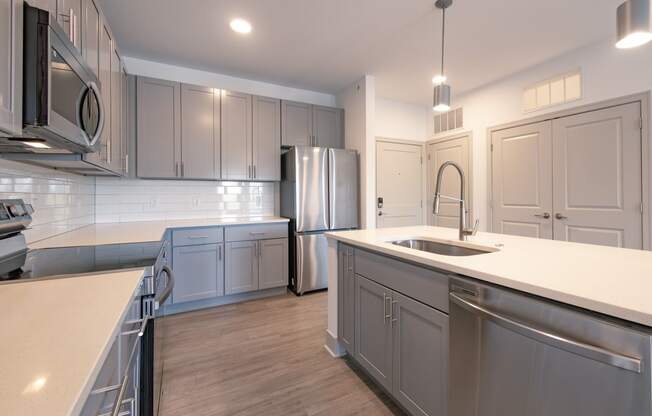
left=376, top=141, right=423, bottom=228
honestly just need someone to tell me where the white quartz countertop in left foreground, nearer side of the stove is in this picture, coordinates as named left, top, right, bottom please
left=0, top=269, right=143, bottom=416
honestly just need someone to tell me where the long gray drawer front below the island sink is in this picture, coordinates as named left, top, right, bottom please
left=354, top=249, right=448, bottom=313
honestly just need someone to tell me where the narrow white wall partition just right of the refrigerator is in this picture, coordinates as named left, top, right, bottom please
left=337, top=75, right=376, bottom=228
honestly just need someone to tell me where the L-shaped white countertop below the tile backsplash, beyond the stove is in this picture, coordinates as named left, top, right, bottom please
left=30, top=217, right=289, bottom=249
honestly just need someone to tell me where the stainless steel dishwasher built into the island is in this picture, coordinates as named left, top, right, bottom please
left=449, top=278, right=652, bottom=416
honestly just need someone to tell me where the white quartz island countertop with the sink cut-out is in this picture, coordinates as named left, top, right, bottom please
left=326, top=226, right=652, bottom=327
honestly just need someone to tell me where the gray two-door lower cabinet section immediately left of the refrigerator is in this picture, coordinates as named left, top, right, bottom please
left=225, top=238, right=288, bottom=295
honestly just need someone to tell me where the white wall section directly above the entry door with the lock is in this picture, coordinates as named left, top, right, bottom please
left=375, top=97, right=434, bottom=141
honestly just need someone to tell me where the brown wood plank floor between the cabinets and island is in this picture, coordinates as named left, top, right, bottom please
left=161, top=292, right=404, bottom=416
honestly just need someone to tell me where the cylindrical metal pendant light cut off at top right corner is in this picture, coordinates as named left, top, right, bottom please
left=616, top=0, right=652, bottom=49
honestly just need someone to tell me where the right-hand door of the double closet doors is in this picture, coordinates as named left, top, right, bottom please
left=553, top=103, right=643, bottom=249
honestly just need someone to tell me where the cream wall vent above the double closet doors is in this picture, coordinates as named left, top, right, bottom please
left=523, top=70, right=582, bottom=113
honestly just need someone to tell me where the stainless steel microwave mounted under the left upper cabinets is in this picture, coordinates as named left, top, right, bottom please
left=20, top=5, right=105, bottom=153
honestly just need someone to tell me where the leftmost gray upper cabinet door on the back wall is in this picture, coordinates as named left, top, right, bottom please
left=136, top=77, right=181, bottom=178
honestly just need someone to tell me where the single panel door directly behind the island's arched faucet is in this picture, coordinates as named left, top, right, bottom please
left=426, top=135, right=471, bottom=228
